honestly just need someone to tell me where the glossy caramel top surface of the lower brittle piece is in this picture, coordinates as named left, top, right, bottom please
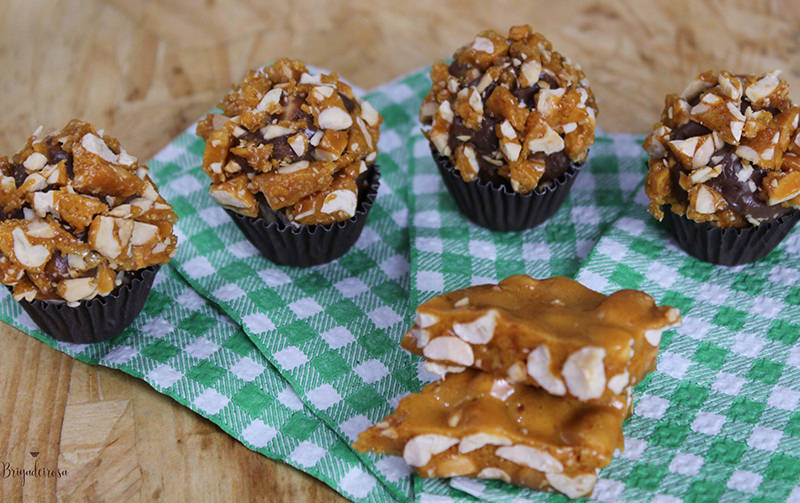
left=354, top=369, right=626, bottom=471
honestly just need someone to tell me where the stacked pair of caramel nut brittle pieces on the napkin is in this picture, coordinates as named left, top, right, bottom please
left=354, top=275, right=680, bottom=498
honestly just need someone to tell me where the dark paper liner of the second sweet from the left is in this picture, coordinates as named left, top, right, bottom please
left=226, top=165, right=380, bottom=267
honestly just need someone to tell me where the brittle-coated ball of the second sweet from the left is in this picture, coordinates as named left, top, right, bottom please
left=196, top=59, right=383, bottom=225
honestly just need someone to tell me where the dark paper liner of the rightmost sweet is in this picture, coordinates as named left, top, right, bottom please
left=663, top=207, right=800, bottom=266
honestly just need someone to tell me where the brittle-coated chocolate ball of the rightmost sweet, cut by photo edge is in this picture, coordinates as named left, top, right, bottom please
left=643, top=70, right=800, bottom=228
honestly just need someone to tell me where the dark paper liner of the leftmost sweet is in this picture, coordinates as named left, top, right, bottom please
left=20, top=265, right=161, bottom=344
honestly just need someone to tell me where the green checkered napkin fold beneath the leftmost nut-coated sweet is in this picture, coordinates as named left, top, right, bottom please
left=0, top=267, right=392, bottom=502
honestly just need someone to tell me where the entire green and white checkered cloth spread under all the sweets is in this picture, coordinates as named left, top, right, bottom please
left=0, top=65, right=800, bottom=503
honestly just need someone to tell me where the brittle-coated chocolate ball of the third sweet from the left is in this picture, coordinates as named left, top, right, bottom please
left=420, top=25, right=597, bottom=194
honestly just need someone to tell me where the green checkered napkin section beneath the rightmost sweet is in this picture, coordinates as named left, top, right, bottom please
left=577, top=191, right=800, bottom=502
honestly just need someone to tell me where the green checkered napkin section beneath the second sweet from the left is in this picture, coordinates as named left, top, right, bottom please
left=157, top=74, right=440, bottom=499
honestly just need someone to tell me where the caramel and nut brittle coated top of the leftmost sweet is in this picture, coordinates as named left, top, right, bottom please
left=0, top=120, right=178, bottom=303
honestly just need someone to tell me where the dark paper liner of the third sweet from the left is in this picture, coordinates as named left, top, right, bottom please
left=431, top=145, right=579, bottom=231
